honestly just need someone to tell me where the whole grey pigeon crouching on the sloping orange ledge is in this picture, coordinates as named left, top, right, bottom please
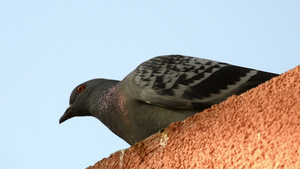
left=59, top=55, right=278, bottom=145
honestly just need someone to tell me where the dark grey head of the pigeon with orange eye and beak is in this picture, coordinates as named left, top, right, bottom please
left=59, top=79, right=104, bottom=123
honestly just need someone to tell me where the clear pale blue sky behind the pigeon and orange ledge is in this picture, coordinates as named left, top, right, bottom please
left=0, top=0, right=300, bottom=169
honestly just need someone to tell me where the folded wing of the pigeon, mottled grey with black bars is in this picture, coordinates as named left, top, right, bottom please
left=126, top=55, right=277, bottom=109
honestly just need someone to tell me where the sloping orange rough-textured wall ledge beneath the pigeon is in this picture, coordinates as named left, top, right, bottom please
left=88, top=66, right=300, bottom=169
